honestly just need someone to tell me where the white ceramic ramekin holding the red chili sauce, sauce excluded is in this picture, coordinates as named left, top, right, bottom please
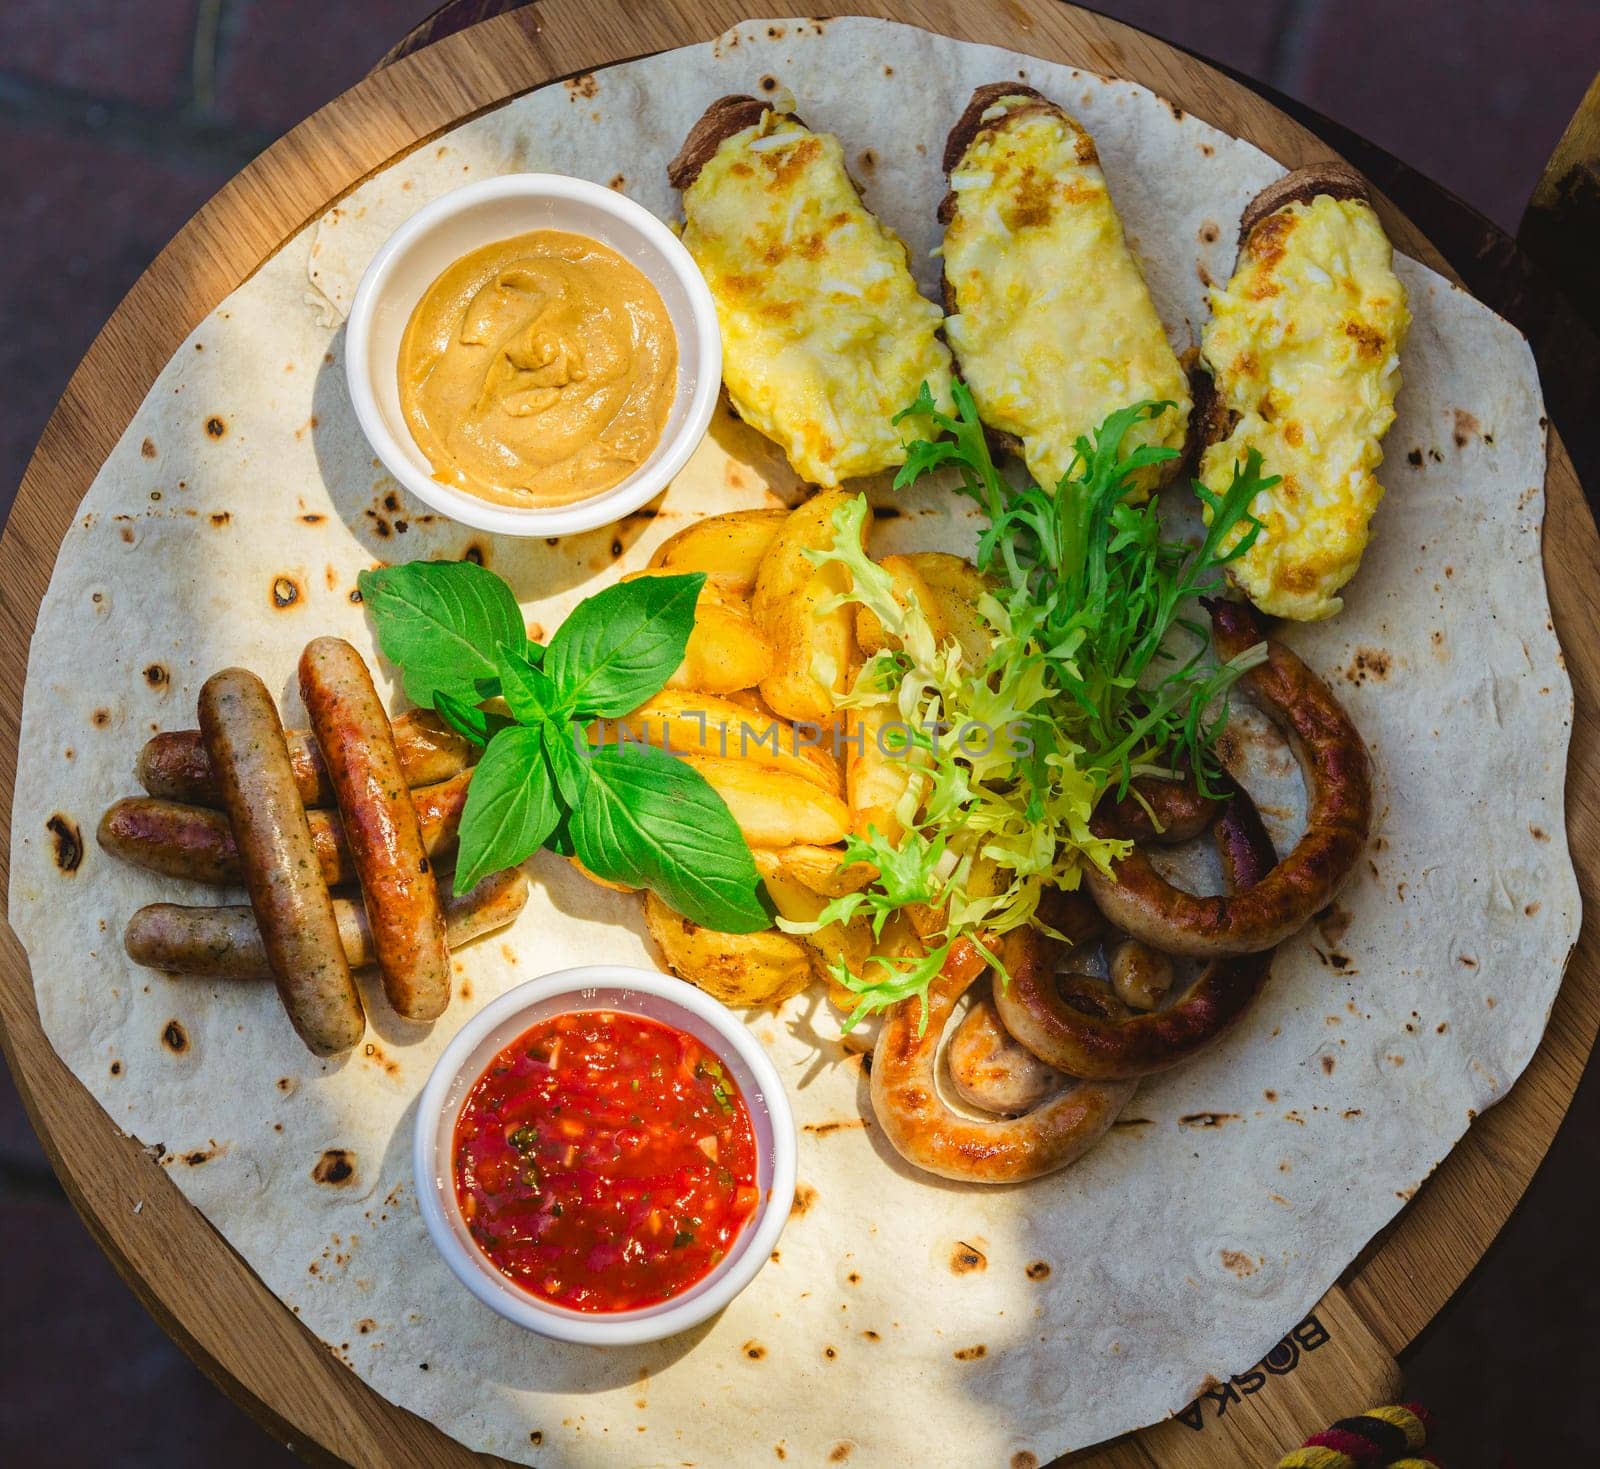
left=411, top=965, right=797, bottom=1346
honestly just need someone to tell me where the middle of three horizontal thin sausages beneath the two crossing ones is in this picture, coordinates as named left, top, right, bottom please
left=98, top=770, right=472, bottom=888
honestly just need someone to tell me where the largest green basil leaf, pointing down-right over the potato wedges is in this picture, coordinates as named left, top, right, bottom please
left=569, top=748, right=771, bottom=933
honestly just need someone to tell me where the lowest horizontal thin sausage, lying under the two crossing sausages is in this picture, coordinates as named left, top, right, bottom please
left=123, top=867, right=528, bottom=979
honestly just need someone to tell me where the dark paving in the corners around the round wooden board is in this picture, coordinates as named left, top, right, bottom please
left=0, top=0, right=1600, bottom=1469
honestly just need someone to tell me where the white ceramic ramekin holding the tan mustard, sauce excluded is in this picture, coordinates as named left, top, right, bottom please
left=344, top=173, right=722, bottom=536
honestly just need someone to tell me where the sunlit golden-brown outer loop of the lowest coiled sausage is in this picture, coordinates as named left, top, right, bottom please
left=872, top=928, right=1136, bottom=1183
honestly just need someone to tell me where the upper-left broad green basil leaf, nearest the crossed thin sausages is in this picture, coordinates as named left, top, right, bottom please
left=355, top=562, right=528, bottom=707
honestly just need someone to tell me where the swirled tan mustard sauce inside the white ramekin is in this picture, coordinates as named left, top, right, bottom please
left=398, top=229, right=678, bottom=506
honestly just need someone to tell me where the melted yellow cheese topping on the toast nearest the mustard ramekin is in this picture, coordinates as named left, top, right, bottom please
left=683, top=112, right=950, bottom=486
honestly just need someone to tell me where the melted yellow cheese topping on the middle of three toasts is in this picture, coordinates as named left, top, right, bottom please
left=944, top=96, right=1189, bottom=490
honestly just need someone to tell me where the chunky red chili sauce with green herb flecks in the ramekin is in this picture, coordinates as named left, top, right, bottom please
left=453, top=1010, right=760, bottom=1312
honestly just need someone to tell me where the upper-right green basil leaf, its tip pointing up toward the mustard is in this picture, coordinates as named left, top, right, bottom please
left=544, top=571, right=706, bottom=718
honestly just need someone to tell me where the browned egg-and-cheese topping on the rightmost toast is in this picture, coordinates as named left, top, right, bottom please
left=1200, top=194, right=1411, bottom=622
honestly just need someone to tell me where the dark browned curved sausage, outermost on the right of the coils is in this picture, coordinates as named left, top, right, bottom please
left=1085, top=602, right=1373, bottom=959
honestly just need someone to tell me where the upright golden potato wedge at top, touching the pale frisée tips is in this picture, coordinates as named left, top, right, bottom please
left=750, top=490, right=856, bottom=725
